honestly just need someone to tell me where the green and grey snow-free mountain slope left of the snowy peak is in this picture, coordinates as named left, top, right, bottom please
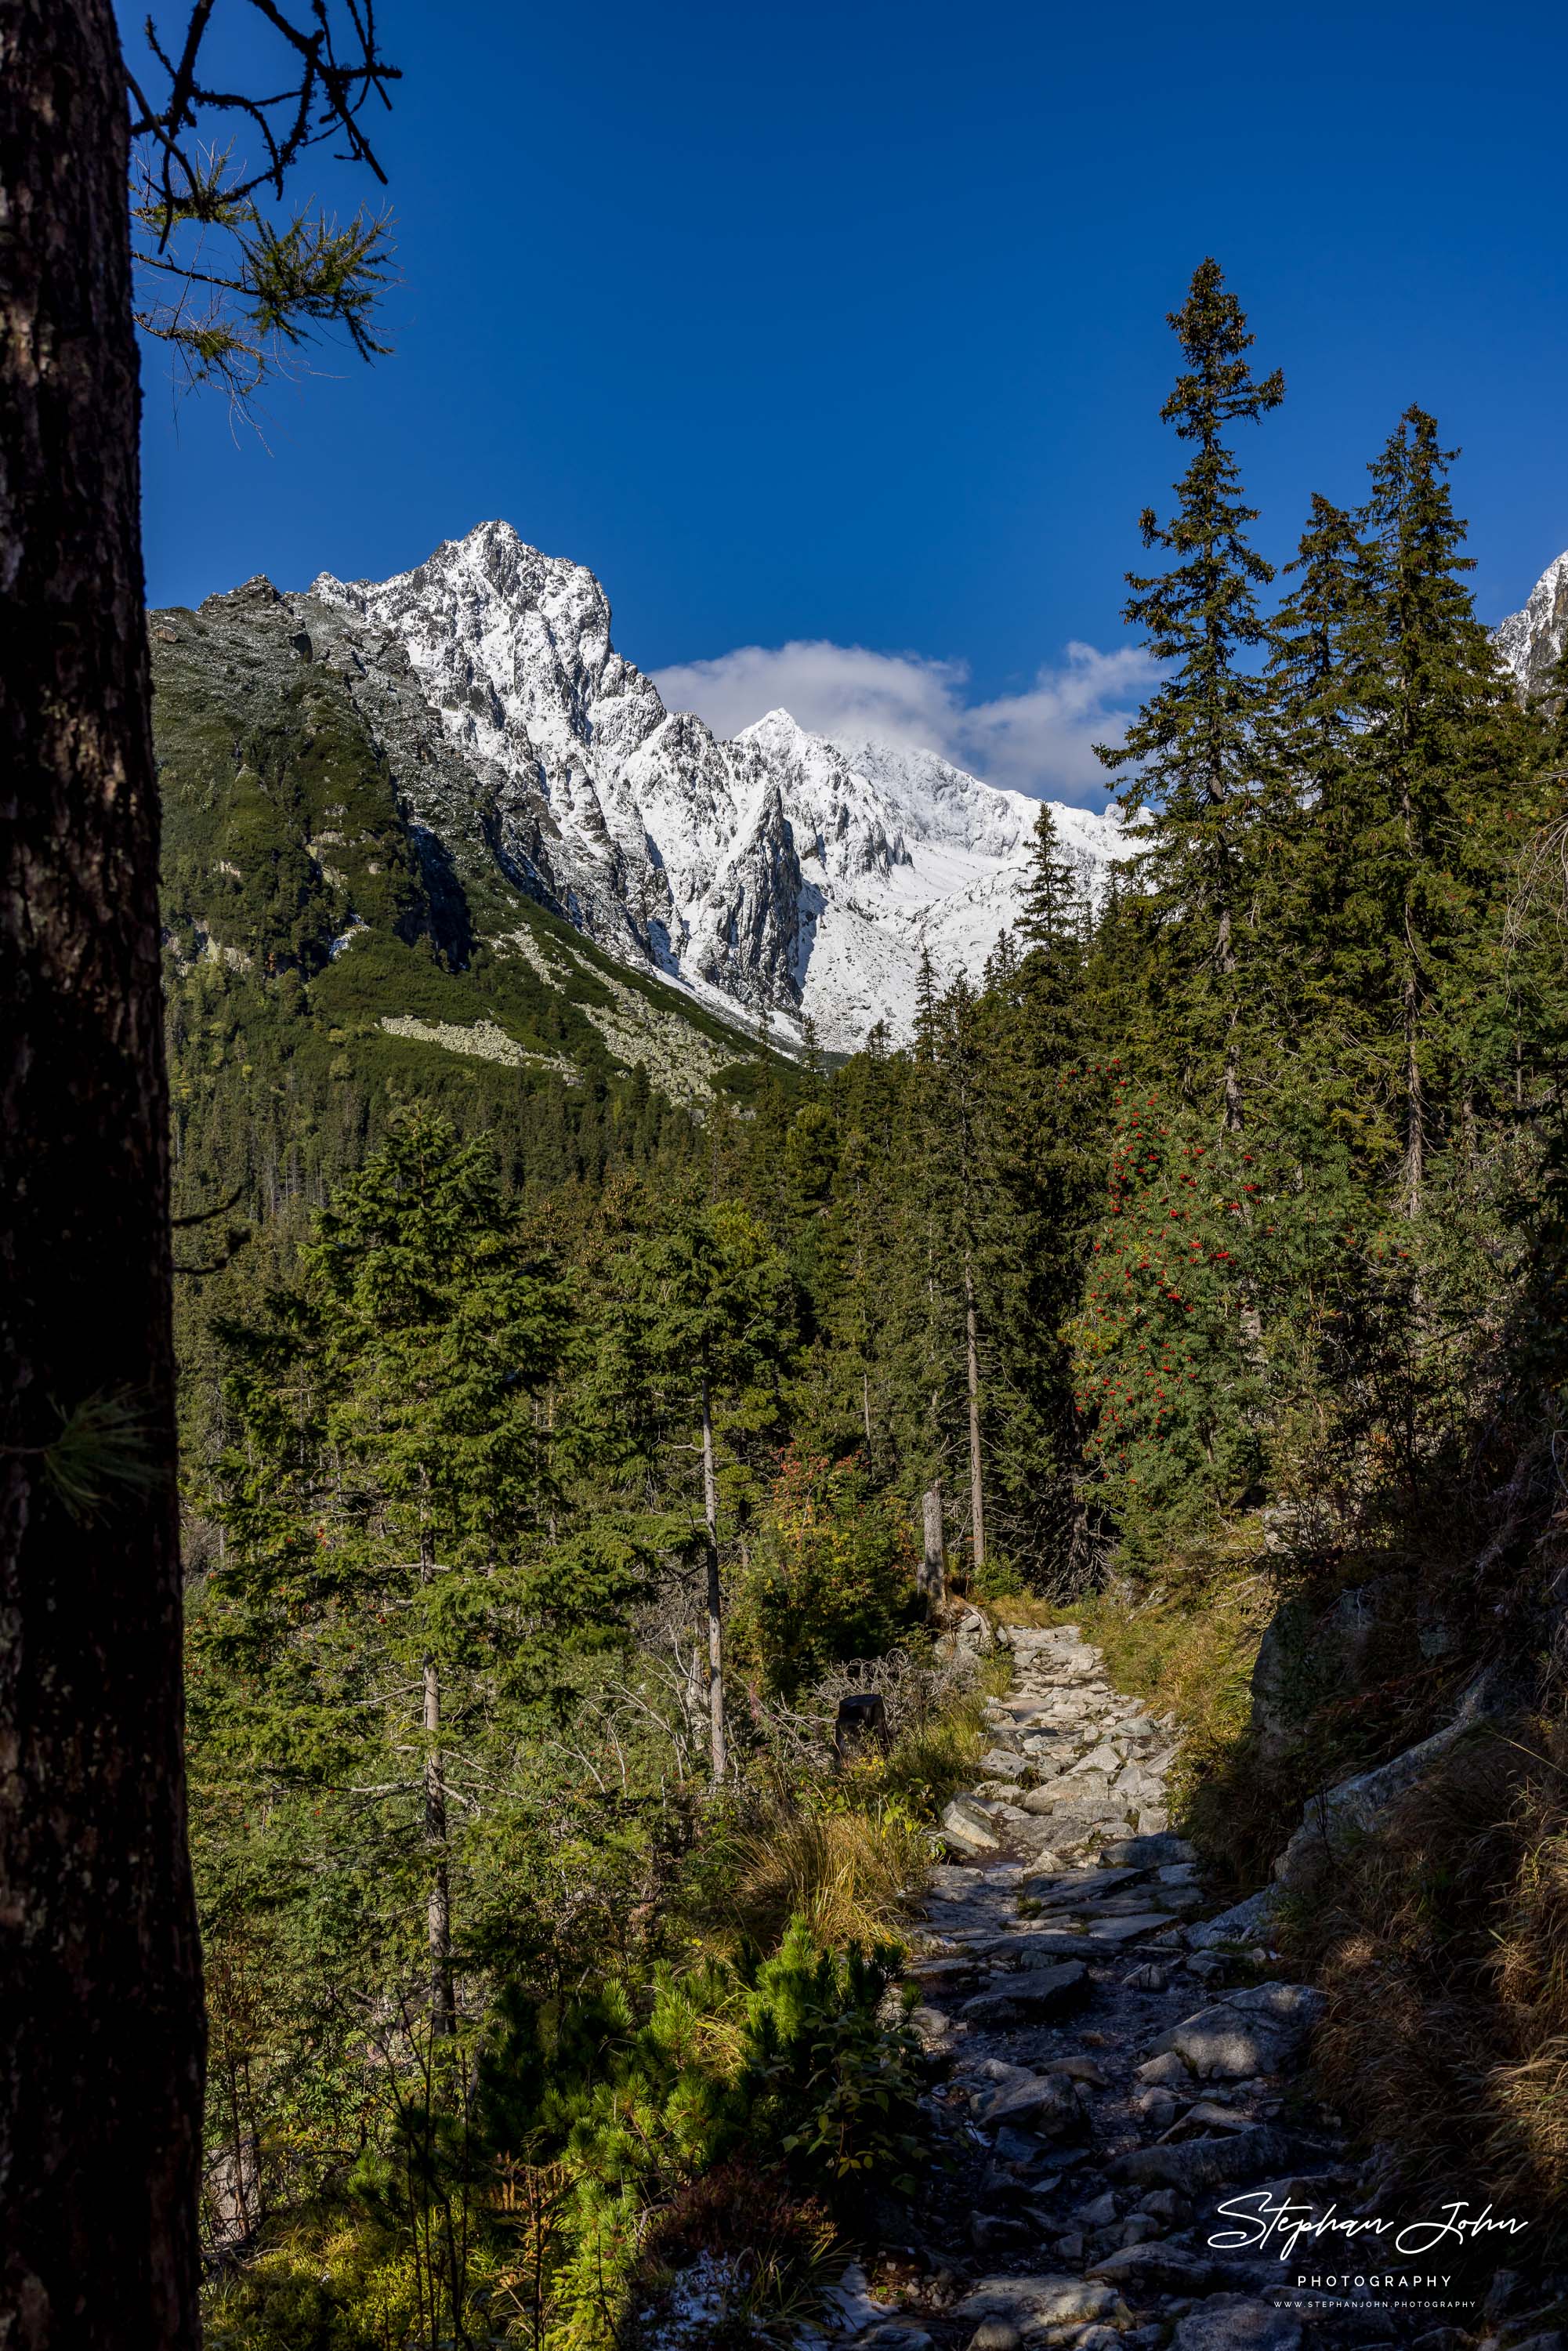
left=150, top=581, right=776, bottom=1105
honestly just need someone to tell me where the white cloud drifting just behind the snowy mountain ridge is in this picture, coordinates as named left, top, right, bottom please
left=654, top=639, right=1150, bottom=804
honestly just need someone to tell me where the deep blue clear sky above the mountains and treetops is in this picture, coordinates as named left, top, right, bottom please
left=132, top=0, right=1568, bottom=799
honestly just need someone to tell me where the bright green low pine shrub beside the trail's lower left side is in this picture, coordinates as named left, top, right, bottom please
left=480, top=1916, right=926, bottom=2346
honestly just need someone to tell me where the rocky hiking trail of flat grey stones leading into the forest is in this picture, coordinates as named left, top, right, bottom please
left=816, top=1625, right=1563, bottom=2351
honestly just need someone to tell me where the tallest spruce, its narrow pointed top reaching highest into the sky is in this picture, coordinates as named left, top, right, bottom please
left=1100, top=261, right=1284, bottom=1128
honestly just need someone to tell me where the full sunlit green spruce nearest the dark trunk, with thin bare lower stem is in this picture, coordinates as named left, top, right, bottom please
left=202, top=1112, right=581, bottom=2036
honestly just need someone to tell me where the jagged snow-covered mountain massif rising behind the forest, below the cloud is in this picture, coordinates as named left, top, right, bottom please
left=310, top=522, right=1124, bottom=1049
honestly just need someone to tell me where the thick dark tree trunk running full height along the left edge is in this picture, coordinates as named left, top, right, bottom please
left=0, top=0, right=202, bottom=2351
